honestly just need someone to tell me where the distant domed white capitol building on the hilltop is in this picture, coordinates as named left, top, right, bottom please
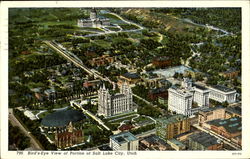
left=77, top=9, right=110, bottom=28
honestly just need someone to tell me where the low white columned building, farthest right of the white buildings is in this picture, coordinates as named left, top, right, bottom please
left=209, top=85, right=237, bottom=103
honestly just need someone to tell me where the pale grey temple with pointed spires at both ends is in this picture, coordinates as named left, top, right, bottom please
left=98, top=83, right=135, bottom=117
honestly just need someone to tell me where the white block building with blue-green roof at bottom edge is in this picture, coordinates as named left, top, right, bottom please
left=109, top=132, right=139, bottom=151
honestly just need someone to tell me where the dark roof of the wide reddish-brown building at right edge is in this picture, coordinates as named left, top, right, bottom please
left=208, top=117, right=242, bottom=133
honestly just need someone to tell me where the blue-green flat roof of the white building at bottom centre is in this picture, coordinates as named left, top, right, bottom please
left=110, top=132, right=138, bottom=144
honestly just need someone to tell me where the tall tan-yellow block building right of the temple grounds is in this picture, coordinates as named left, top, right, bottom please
left=156, top=114, right=190, bottom=141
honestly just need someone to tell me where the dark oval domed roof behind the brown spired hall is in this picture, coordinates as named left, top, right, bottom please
left=41, top=110, right=85, bottom=127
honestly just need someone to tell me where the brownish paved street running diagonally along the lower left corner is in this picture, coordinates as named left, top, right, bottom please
left=9, top=109, right=42, bottom=150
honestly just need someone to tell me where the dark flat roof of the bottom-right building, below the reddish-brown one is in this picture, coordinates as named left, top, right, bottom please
left=188, top=132, right=218, bottom=147
